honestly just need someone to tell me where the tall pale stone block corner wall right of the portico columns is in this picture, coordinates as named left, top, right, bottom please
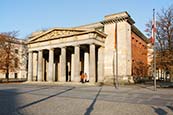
left=104, top=21, right=132, bottom=84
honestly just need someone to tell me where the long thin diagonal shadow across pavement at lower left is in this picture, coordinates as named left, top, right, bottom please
left=17, top=87, right=75, bottom=110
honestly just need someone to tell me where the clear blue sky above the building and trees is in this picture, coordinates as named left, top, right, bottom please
left=0, top=0, right=173, bottom=38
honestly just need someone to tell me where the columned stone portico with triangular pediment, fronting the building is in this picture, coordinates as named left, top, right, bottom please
left=28, top=28, right=106, bottom=83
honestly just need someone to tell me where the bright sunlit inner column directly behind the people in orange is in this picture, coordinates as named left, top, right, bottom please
left=84, top=52, right=89, bottom=80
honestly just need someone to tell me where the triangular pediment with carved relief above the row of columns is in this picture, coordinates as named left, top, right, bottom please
left=29, top=28, right=85, bottom=42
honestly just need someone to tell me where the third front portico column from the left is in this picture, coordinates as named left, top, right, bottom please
left=48, top=49, right=54, bottom=82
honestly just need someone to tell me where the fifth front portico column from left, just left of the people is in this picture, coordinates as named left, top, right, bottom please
left=74, top=46, right=80, bottom=82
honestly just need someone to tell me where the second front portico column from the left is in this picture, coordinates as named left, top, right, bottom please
left=38, top=50, right=43, bottom=81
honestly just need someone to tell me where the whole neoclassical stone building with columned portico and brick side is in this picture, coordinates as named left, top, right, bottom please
left=28, top=12, right=148, bottom=83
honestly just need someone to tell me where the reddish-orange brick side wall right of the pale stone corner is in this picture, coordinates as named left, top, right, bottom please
left=131, top=32, right=148, bottom=77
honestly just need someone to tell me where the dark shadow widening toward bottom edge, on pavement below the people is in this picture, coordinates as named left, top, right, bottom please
left=84, top=87, right=102, bottom=115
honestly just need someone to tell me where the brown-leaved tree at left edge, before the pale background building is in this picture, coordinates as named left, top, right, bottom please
left=0, top=31, right=19, bottom=80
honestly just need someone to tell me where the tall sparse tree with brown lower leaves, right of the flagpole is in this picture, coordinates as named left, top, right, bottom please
left=146, top=5, right=173, bottom=81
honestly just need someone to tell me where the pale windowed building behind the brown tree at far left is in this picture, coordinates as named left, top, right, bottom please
left=0, top=34, right=27, bottom=80
